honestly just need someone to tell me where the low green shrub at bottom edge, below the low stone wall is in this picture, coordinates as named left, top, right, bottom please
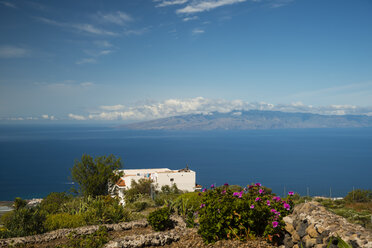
left=60, top=226, right=109, bottom=248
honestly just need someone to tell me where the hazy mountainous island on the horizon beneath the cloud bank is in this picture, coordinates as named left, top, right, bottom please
left=120, top=110, right=372, bottom=130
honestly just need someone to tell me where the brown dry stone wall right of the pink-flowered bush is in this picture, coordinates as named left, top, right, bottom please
left=284, top=202, right=372, bottom=248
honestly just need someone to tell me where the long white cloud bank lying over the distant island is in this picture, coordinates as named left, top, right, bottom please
left=88, top=97, right=372, bottom=121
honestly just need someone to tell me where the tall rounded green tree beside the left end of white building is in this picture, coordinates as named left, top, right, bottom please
left=71, top=154, right=121, bottom=196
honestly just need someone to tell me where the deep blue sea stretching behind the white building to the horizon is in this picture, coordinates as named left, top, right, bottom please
left=0, top=125, right=372, bottom=200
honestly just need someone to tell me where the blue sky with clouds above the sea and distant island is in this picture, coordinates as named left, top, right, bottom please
left=0, top=0, right=372, bottom=121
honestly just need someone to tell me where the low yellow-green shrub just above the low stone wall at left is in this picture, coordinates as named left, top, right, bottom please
left=44, top=213, right=86, bottom=231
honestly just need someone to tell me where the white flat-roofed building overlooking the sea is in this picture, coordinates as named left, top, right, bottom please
left=115, top=167, right=200, bottom=203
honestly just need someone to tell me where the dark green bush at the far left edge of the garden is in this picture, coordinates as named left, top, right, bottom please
left=1, top=199, right=45, bottom=237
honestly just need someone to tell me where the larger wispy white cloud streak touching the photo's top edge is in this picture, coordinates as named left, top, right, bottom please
left=176, top=0, right=246, bottom=14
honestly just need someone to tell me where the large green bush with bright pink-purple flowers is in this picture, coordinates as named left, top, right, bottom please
left=199, top=183, right=293, bottom=243
